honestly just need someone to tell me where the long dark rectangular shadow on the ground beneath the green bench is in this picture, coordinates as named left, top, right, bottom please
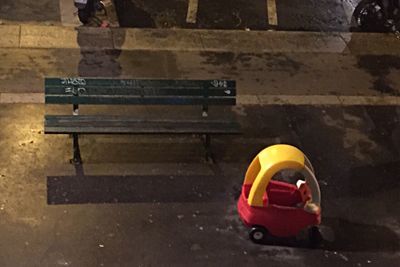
left=47, top=165, right=226, bottom=205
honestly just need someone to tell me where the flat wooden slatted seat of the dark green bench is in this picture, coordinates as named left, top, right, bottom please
left=45, top=115, right=240, bottom=134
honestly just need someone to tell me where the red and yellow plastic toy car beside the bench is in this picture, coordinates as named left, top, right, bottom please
left=237, top=145, right=321, bottom=243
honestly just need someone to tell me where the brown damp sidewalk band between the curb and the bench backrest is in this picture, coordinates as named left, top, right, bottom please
left=0, top=46, right=400, bottom=96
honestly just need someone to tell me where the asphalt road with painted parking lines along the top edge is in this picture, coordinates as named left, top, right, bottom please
left=0, top=0, right=366, bottom=31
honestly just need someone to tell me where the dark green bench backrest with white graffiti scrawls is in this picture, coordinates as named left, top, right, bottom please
left=45, top=78, right=236, bottom=106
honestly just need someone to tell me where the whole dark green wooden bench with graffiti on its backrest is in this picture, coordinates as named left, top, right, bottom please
left=44, top=78, right=240, bottom=164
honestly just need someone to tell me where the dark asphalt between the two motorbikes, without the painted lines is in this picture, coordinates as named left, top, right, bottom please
left=115, top=0, right=357, bottom=32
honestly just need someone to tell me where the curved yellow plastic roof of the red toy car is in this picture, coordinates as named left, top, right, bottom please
left=244, top=145, right=305, bottom=207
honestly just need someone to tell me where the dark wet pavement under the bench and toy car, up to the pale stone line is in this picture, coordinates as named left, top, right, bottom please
left=0, top=104, right=400, bottom=266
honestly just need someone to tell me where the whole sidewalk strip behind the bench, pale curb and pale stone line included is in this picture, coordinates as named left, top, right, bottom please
left=0, top=25, right=400, bottom=105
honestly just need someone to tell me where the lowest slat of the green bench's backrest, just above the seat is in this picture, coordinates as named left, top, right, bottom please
left=45, top=95, right=236, bottom=105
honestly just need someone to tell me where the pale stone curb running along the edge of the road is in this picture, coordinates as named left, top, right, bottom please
left=0, top=24, right=400, bottom=55
